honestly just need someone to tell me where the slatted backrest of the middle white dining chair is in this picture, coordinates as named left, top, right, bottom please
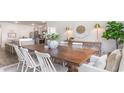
left=20, top=47, right=36, bottom=67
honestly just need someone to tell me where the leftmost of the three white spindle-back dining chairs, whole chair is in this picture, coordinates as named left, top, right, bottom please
left=13, top=45, right=25, bottom=72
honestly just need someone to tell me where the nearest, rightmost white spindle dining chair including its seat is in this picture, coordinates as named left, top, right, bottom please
left=35, top=51, right=68, bottom=72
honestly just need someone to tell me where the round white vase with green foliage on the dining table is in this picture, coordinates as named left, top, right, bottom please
left=47, top=33, right=60, bottom=49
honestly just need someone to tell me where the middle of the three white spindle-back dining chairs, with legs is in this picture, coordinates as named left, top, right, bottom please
left=20, top=47, right=40, bottom=72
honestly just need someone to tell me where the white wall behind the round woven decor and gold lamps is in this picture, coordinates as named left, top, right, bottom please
left=48, top=21, right=120, bottom=52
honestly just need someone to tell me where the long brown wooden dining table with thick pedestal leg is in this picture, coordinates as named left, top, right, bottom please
left=22, top=44, right=96, bottom=72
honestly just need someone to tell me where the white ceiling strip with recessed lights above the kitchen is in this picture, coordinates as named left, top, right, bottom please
left=4, top=21, right=46, bottom=26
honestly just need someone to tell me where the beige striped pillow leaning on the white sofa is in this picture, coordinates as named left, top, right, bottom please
left=105, top=49, right=122, bottom=72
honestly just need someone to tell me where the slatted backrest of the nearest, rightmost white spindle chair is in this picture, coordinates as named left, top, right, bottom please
left=35, top=51, right=56, bottom=72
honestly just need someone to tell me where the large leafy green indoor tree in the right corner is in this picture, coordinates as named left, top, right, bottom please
left=102, top=21, right=124, bottom=49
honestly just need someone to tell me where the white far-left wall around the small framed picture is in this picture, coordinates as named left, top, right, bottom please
left=0, top=22, right=33, bottom=47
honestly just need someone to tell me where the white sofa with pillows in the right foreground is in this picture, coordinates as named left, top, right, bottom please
left=78, top=47, right=124, bottom=72
